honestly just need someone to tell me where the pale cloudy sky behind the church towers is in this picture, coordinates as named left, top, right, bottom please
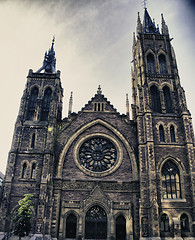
left=0, top=0, right=195, bottom=173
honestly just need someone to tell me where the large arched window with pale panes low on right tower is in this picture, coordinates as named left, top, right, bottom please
left=162, top=160, right=182, bottom=198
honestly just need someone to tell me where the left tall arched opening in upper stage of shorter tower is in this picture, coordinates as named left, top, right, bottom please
left=27, top=87, right=39, bottom=121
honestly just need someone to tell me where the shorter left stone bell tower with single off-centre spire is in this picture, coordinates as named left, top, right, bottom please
left=0, top=39, right=63, bottom=232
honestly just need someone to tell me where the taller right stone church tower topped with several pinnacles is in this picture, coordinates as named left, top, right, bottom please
left=132, top=8, right=195, bottom=239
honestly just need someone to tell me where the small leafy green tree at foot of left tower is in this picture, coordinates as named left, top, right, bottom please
left=13, top=194, right=33, bottom=239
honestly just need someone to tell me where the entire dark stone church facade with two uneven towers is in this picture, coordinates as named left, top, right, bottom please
left=0, top=9, right=195, bottom=240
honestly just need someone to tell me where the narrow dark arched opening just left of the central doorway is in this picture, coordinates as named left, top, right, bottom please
left=66, top=214, right=77, bottom=239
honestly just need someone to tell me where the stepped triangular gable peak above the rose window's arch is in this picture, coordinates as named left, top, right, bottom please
left=81, top=86, right=117, bottom=113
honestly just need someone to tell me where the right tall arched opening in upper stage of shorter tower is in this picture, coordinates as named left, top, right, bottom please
left=41, top=88, right=52, bottom=121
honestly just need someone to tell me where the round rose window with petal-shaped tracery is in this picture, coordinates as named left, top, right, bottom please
left=79, top=137, right=117, bottom=172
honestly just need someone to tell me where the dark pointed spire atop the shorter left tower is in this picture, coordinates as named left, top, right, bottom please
left=36, top=36, right=56, bottom=73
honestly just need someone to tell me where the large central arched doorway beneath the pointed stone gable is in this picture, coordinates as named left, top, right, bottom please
left=85, top=206, right=107, bottom=239
